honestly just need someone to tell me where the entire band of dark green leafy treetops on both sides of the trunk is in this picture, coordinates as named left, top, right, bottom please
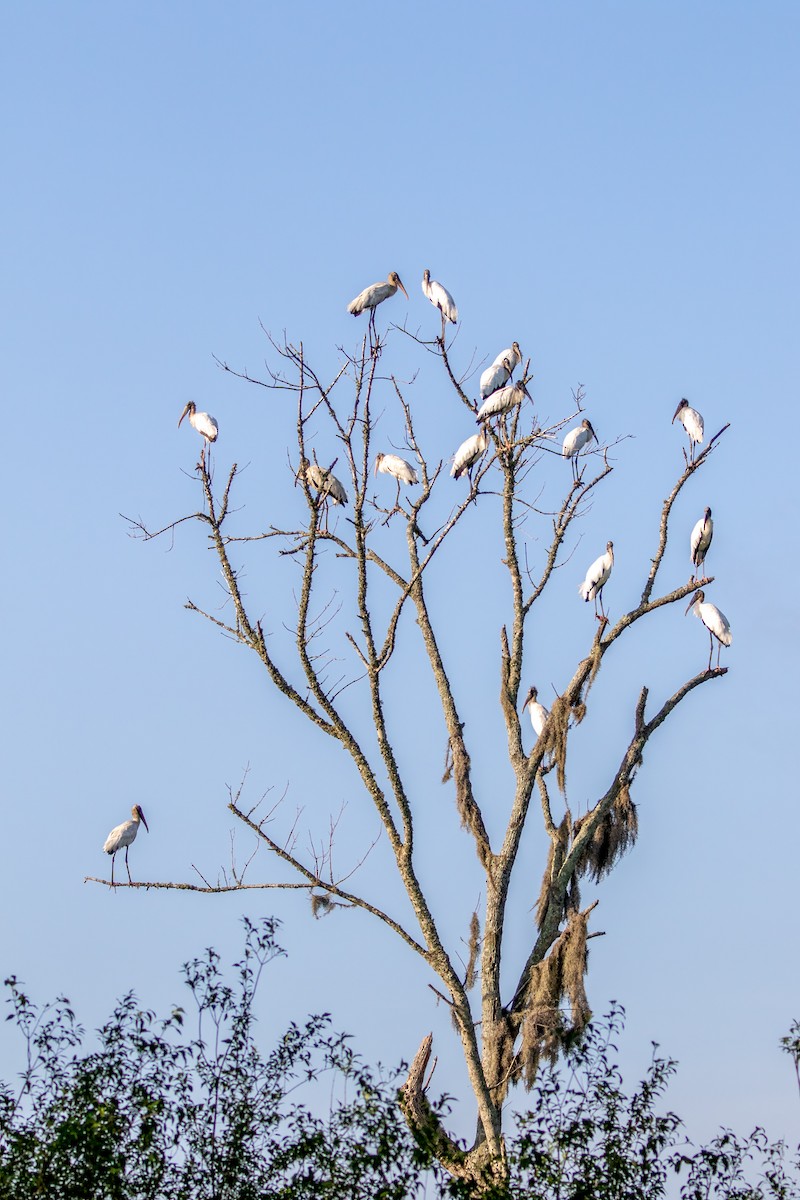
left=0, top=920, right=800, bottom=1200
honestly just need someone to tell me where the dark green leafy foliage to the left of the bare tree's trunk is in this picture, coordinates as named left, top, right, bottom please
left=0, top=920, right=431, bottom=1200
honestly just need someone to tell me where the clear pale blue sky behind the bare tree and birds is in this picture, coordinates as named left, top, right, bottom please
left=0, top=0, right=800, bottom=1152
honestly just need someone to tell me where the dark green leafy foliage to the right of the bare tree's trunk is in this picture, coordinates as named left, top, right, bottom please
left=507, top=1007, right=800, bottom=1200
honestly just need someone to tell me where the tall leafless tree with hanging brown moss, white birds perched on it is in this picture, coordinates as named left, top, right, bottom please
left=98, top=328, right=726, bottom=1194
